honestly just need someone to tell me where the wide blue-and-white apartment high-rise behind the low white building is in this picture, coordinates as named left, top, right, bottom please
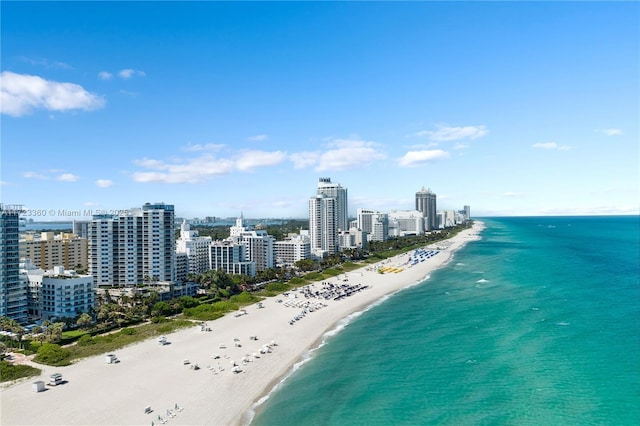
left=89, top=203, right=176, bottom=286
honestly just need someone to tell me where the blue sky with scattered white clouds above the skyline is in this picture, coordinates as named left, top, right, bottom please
left=0, top=1, right=640, bottom=220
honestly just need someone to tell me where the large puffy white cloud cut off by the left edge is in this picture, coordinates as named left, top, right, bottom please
left=0, top=71, right=105, bottom=117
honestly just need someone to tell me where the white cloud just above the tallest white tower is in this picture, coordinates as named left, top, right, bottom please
left=289, top=139, right=387, bottom=172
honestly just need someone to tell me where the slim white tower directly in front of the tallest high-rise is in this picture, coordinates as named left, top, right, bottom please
left=309, top=194, right=338, bottom=256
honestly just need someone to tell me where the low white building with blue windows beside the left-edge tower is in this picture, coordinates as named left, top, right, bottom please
left=20, top=259, right=96, bottom=320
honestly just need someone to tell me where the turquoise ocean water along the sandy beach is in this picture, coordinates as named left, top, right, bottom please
left=252, top=216, right=640, bottom=425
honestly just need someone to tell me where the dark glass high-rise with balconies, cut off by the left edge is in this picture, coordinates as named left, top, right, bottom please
left=0, top=203, right=28, bottom=323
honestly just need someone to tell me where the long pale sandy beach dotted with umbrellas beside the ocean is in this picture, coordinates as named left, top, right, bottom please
left=0, top=222, right=482, bottom=426
